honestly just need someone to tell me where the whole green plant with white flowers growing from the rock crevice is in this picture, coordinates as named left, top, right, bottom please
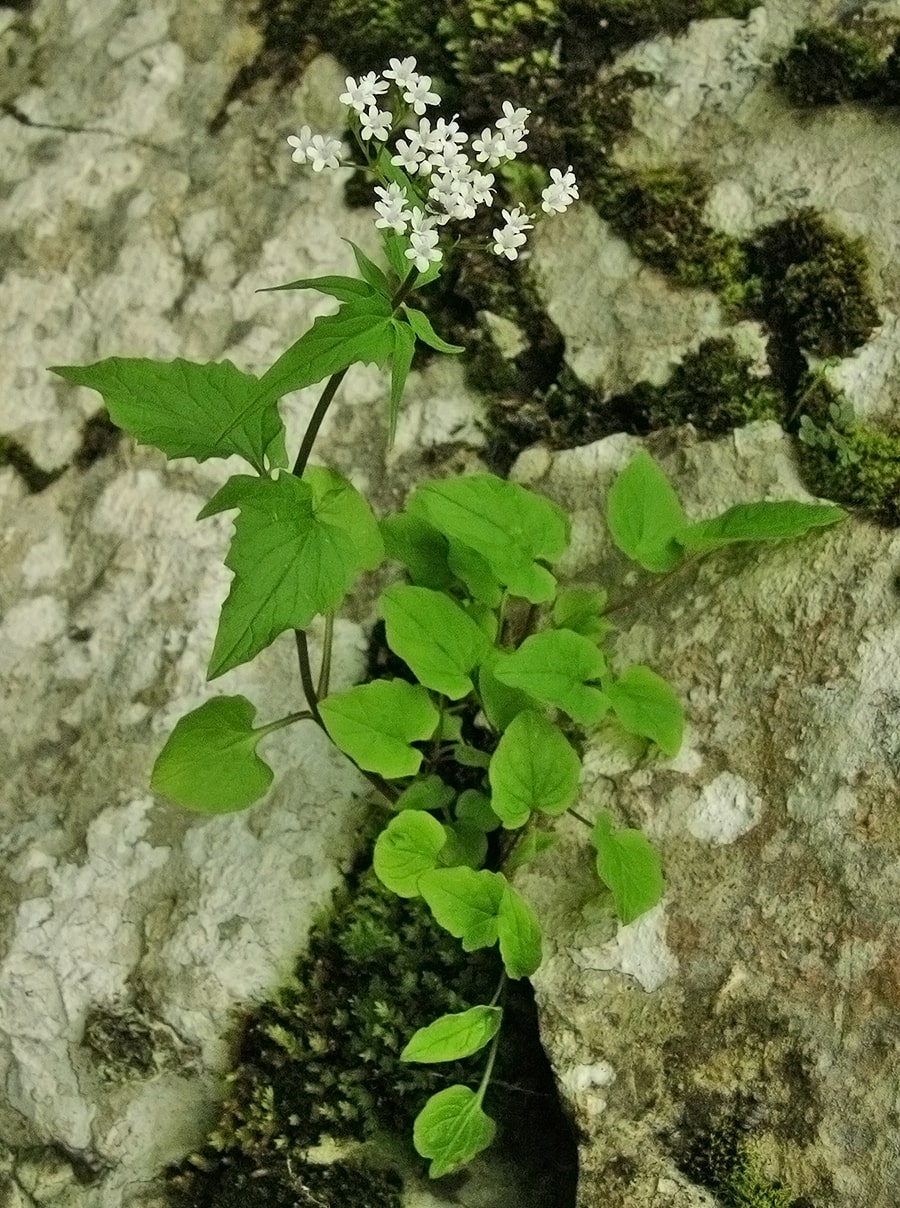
left=54, top=58, right=843, bottom=1177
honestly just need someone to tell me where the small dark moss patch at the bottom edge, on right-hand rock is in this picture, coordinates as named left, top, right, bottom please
left=684, top=1122, right=795, bottom=1208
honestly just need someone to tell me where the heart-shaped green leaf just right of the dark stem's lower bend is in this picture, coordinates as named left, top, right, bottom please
left=319, top=679, right=440, bottom=780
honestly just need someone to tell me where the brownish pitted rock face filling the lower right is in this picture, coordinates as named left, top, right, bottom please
left=513, top=424, right=900, bottom=1208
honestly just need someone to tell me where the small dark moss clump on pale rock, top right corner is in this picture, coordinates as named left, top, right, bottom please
left=776, top=25, right=883, bottom=105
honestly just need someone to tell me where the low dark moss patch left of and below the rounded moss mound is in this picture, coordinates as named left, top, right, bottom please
left=609, top=336, right=783, bottom=436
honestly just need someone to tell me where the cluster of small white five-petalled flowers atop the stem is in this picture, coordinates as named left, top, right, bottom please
left=288, top=57, right=579, bottom=272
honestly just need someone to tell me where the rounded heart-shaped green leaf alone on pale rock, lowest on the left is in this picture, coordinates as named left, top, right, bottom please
left=150, top=696, right=272, bottom=814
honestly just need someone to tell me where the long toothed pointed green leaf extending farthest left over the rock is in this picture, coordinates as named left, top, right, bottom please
left=51, top=356, right=284, bottom=474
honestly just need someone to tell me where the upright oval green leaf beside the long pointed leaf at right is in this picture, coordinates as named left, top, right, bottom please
left=606, top=449, right=687, bottom=573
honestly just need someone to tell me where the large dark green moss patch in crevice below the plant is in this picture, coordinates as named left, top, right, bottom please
left=165, top=871, right=497, bottom=1208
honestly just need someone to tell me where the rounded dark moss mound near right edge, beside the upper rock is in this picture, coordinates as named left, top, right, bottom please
left=753, top=209, right=878, bottom=356
